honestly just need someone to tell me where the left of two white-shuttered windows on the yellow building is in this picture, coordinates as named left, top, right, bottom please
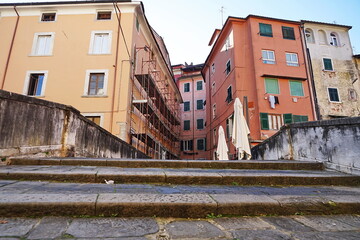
left=32, top=33, right=55, bottom=56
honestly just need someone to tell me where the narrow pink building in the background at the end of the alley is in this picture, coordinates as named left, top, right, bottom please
left=173, top=63, right=208, bottom=160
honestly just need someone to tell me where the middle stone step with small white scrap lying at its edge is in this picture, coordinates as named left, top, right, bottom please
left=0, top=165, right=360, bottom=186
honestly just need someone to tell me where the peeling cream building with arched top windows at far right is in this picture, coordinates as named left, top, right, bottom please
left=301, top=20, right=360, bottom=119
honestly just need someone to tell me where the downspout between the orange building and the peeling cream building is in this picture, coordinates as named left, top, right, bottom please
left=299, top=25, right=320, bottom=121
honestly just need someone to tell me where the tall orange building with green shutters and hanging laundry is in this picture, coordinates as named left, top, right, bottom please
left=202, top=15, right=315, bottom=158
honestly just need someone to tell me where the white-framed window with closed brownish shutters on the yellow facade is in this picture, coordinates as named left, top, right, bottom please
left=84, top=70, right=109, bottom=96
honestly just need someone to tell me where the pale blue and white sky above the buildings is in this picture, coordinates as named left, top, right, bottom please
left=0, top=0, right=360, bottom=65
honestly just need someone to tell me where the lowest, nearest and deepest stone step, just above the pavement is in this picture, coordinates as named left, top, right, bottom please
left=0, top=180, right=360, bottom=218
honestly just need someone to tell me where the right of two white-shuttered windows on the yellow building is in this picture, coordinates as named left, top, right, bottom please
left=89, top=31, right=112, bottom=54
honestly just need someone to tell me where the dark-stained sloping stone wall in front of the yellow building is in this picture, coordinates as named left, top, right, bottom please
left=0, top=90, right=148, bottom=159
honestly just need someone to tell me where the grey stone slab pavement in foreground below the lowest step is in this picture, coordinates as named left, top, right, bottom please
left=0, top=215, right=360, bottom=240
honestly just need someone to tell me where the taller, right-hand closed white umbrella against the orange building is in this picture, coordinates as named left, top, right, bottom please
left=231, top=98, right=251, bottom=159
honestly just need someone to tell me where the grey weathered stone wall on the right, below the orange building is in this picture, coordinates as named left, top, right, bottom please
left=251, top=117, right=360, bottom=175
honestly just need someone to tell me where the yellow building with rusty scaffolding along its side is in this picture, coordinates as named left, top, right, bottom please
left=0, top=0, right=182, bottom=158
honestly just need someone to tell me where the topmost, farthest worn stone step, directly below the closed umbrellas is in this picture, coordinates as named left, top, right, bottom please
left=9, top=158, right=324, bottom=170
